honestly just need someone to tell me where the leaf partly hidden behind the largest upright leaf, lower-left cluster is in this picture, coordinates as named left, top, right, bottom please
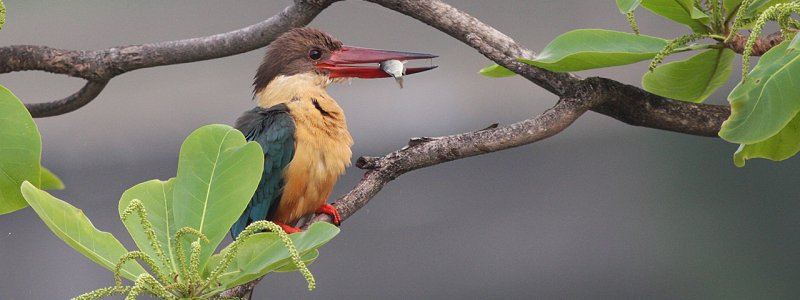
left=119, top=178, right=178, bottom=273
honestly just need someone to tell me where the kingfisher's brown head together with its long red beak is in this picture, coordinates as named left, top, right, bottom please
left=253, top=27, right=437, bottom=94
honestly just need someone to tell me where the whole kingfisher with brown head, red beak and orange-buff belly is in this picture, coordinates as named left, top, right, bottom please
left=230, top=27, right=437, bottom=239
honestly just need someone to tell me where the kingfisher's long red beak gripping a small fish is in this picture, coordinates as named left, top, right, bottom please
left=316, top=46, right=438, bottom=78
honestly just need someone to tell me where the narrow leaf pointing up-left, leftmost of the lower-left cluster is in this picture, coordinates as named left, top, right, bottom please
left=21, top=181, right=145, bottom=280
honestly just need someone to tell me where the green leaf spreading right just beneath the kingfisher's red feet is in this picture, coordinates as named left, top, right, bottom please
left=208, top=222, right=339, bottom=289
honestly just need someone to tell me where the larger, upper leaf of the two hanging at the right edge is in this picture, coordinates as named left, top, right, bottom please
left=719, top=42, right=800, bottom=144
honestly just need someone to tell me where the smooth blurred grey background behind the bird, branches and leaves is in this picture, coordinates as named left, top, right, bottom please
left=0, top=0, right=800, bottom=299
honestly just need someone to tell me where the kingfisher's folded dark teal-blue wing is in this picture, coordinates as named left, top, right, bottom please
left=231, top=104, right=295, bottom=239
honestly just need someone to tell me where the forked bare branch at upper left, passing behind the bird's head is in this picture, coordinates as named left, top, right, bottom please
left=0, top=0, right=339, bottom=117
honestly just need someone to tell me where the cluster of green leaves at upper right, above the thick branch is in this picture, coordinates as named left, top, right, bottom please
left=480, top=0, right=800, bottom=166
